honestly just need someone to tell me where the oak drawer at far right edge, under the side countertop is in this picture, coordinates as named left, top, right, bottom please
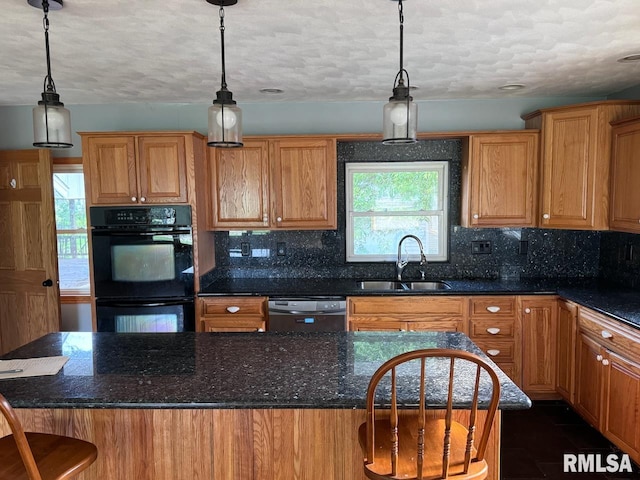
left=578, top=307, right=640, bottom=361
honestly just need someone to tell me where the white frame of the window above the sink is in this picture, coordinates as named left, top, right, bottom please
left=345, top=160, right=450, bottom=263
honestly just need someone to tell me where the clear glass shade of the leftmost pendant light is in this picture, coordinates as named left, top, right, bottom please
left=33, top=95, right=73, bottom=148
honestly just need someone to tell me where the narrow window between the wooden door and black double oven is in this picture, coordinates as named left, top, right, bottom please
left=53, top=164, right=89, bottom=295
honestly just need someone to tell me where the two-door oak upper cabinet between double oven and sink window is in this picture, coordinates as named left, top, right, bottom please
left=208, top=137, right=337, bottom=230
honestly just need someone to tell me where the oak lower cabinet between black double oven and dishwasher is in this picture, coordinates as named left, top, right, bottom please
left=198, top=296, right=268, bottom=332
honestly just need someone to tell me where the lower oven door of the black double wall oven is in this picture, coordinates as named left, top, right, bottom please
left=96, top=298, right=195, bottom=333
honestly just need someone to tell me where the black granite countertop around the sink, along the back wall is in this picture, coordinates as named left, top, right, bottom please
left=199, top=278, right=640, bottom=328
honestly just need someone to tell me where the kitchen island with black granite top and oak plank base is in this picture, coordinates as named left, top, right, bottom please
left=0, top=332, right=531, bottom=480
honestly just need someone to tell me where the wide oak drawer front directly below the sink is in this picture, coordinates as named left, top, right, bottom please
left=349, top=296, right=465, bottom=318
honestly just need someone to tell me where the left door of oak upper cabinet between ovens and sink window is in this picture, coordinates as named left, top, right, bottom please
left=208, top=140, right=269, bottom=230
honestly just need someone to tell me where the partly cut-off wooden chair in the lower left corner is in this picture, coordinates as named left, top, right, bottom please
left=0, top=395, right=98, bottom=480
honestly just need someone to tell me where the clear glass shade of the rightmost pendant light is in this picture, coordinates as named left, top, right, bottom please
left=382, top=97, right=418, bottom=145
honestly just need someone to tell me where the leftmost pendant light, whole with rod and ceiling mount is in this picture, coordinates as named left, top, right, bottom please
left=28, top=0, right=73, bottom=148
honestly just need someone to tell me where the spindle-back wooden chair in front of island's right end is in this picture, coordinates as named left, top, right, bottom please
left=358, top=349, right=500, bottom=480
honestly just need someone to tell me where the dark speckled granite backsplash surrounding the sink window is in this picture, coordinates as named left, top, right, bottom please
left=202, top=139, right=620, bottom=285
